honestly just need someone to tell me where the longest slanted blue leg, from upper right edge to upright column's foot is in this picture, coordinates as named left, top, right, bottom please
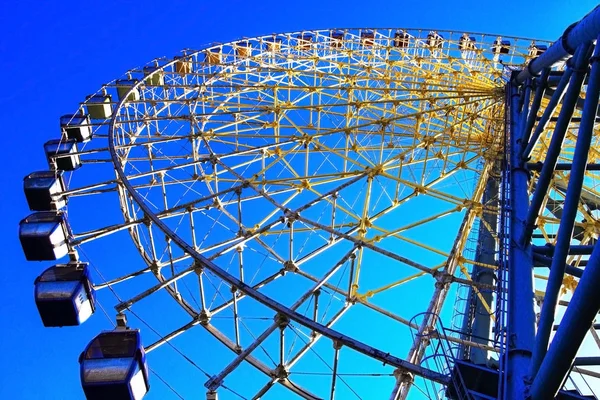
left=528, top=44, right=599, bottom=377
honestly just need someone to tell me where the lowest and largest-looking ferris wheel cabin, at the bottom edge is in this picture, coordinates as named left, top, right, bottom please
left=79, top=329, right=150, bottom=400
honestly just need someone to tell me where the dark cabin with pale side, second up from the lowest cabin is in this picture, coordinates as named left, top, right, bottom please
left=34, top=263, right=95, bottom=327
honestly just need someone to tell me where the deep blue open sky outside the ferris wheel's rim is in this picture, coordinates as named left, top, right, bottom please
left=0, top=0, right=596, bottom=399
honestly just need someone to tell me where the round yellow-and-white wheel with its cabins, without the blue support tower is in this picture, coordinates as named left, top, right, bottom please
left=20, top=28, right=593, bottom=399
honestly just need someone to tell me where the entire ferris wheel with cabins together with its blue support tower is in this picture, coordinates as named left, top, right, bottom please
left=19, top=3, right=600, bottom=400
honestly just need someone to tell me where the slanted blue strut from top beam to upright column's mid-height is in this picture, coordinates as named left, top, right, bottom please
left=516, top=43, right=591, bottom=243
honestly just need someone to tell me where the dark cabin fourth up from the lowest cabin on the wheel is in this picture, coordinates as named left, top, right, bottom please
left=23, top=171, right=67, bottom=211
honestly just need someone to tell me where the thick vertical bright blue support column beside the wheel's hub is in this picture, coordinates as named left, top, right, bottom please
left=504, top=78, right=535, bottom=400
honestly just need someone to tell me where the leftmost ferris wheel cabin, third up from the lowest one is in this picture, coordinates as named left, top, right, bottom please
left=19, top=211, right=69, bottom=261
